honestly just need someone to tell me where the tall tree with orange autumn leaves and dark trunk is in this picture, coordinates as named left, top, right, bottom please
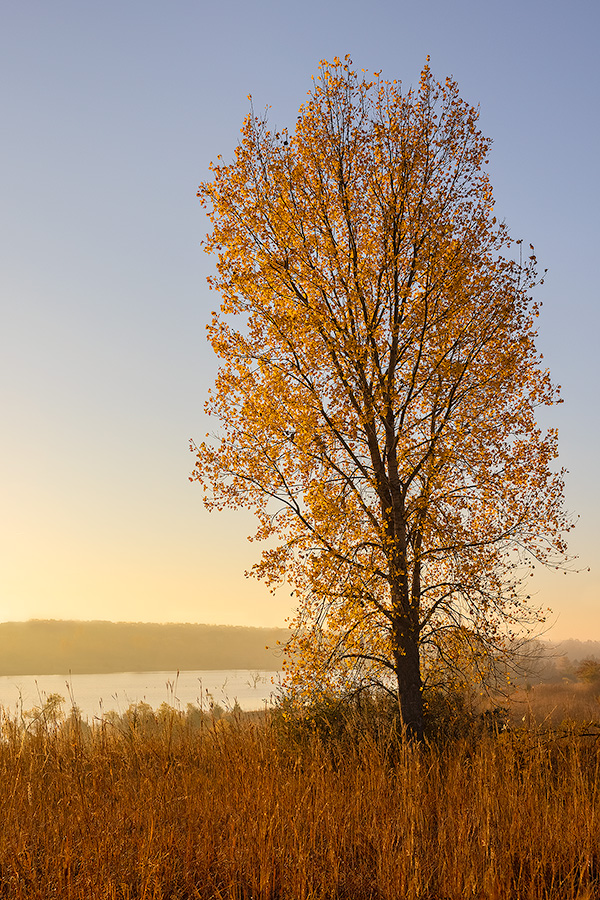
left=192, top=57, right=569, bottom=737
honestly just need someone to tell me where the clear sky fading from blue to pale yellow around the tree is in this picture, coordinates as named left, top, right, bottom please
left=0, top=0, right=600, bottom=640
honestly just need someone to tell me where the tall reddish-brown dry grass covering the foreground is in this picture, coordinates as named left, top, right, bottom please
left=0, top=689, right=600, bottom=900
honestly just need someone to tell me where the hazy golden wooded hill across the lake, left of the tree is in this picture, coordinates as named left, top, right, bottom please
left=0, top=619, right=289, bottom=675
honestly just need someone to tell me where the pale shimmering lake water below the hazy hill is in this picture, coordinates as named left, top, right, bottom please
left=0, top=669, right=279, bottom=722
